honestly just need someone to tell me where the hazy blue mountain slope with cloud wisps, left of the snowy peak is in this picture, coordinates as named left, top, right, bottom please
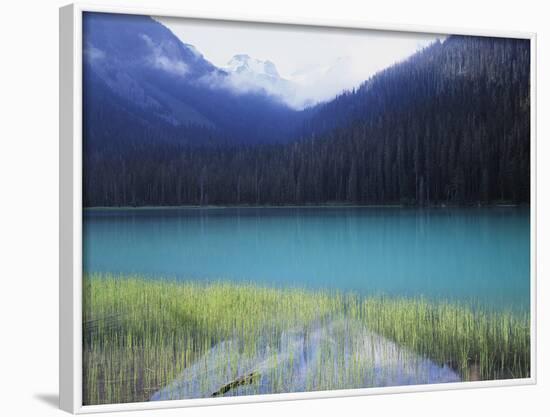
left=83, top=12, right=304, bottom=152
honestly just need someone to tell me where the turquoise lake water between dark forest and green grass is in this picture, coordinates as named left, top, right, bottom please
left=83, top=207, right=530, bottom=309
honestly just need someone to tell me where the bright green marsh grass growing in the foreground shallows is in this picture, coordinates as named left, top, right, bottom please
left=83, top=275, right=530, bottom=404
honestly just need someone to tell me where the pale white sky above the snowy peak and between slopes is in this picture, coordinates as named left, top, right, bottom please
left=155, top=17, right=444, bottom=108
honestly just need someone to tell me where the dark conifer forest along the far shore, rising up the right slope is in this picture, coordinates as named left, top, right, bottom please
left=84, top=36, right=530, bottom=206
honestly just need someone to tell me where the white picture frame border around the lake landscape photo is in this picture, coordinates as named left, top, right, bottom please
left=59, top=3, right=537, bottom=414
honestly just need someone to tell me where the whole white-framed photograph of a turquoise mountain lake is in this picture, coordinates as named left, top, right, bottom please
left=60, top=5, right=536, bottom=413
